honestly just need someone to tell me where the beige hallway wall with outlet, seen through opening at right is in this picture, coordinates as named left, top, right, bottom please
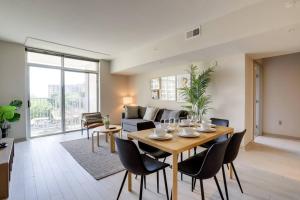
left=263, top=53, right=300, bottom=138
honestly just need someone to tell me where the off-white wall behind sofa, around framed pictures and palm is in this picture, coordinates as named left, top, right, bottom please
left=129, top=54, right=245, bottom=134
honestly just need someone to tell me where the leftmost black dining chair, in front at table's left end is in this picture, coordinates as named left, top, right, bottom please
left=116, top=137, right=170, bottom=200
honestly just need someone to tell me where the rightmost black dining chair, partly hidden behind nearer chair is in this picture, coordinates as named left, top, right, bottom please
left=222, top=130, right=246, bottom=200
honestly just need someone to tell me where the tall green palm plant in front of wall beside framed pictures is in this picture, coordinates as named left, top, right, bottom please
left=180, top=63, right=217, bottom=121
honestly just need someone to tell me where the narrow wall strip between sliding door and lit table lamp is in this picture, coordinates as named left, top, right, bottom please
left=100, top=60, right=128, bottom=124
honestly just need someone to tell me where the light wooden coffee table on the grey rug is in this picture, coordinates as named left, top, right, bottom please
left=92, top=125, right=122, bottom=153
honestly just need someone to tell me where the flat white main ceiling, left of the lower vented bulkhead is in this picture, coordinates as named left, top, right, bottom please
left=0, top=0, right=261, bottom=58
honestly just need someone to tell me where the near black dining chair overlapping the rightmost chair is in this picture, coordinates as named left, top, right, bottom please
left=176, top=139, right=230, bottom=200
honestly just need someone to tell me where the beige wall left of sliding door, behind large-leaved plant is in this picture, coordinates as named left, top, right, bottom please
left=0, top=41, right=26, bottom=139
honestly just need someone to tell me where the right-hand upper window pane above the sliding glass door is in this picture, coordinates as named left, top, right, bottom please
left=64, top=58, right=98, bottom=71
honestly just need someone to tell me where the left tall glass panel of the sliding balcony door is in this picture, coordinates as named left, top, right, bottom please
left=29, top=67, right=62, bottom=137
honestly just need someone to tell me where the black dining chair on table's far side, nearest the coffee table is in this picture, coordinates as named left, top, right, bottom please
left=137, top=121, right=171, bottom=193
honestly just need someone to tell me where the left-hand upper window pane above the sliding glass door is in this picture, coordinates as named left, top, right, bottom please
left=27, top=52, right=61, bottom=66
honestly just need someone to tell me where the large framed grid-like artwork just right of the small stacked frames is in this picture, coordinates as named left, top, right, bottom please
left=161, top=76, right=176, bottom=101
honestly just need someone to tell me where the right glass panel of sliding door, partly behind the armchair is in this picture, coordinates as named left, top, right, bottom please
left=65, top=72, right=89, bottom=131
